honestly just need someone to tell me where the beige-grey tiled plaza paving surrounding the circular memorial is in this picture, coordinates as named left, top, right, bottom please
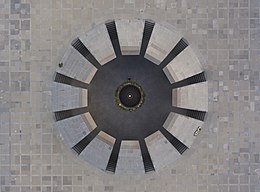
left=0, top=0, right=260, bottom=192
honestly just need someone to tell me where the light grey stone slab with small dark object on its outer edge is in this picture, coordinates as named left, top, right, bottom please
left=56, top=46, right=97, bottom=83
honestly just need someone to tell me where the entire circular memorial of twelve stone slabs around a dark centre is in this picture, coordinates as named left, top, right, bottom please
left=53, top=19, right=208, bottom=174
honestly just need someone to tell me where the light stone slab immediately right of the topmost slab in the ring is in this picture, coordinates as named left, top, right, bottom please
left=145, top=23, right=181, bottom=65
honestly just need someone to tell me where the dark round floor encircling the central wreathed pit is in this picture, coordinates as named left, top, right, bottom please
left=88, top=56, right=172, bottom=140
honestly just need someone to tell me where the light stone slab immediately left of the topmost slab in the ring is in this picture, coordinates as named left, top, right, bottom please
left=80, top=24, right=116, bottom=65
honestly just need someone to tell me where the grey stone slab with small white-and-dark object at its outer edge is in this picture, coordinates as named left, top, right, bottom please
left=163, top=113, right=203, bottom=148
